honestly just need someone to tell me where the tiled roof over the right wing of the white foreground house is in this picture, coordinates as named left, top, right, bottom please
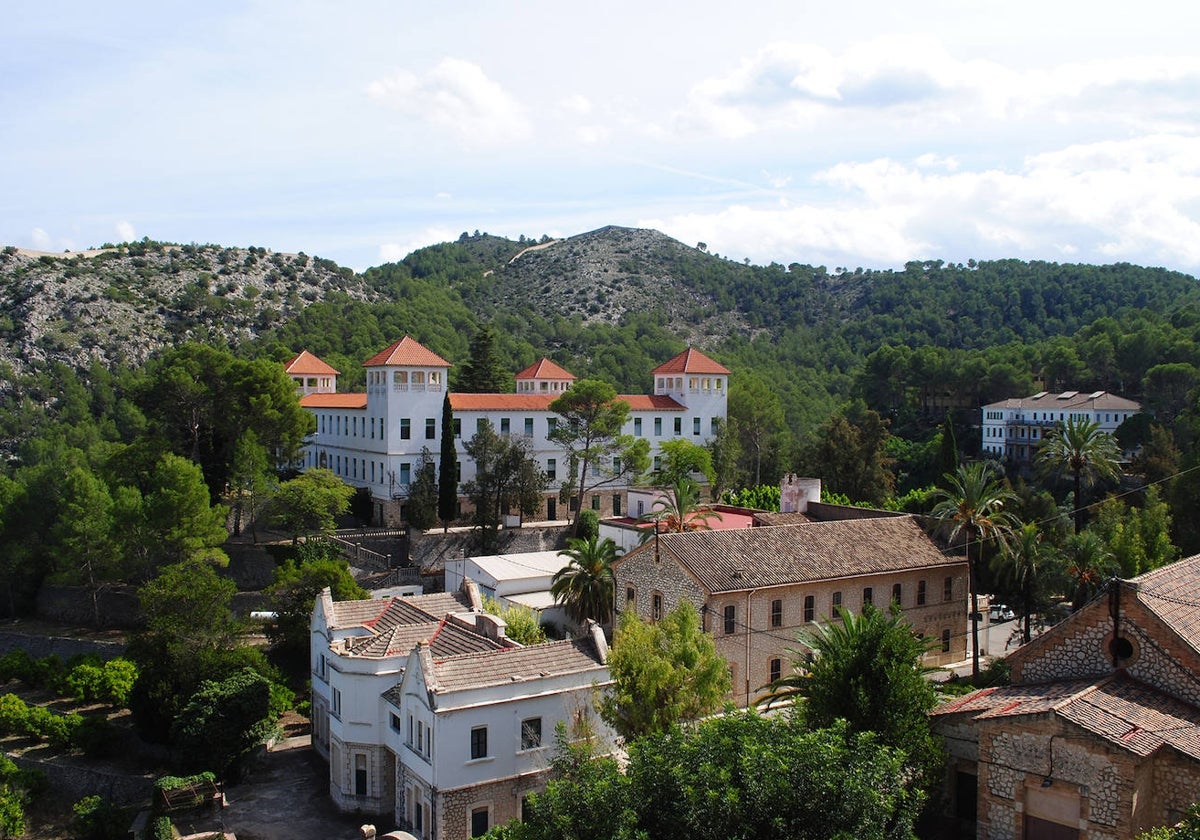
left=434, top=640, right=606, bottom=692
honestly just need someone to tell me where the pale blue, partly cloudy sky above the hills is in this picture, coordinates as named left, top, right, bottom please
left=0, top=0, right=1200, bottom=275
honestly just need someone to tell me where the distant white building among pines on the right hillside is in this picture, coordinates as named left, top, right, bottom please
left=983, top=391, right=1141, bottom=463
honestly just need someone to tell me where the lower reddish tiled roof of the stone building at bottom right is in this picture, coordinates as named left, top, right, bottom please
left=930, top=672, right=1200, bottom=760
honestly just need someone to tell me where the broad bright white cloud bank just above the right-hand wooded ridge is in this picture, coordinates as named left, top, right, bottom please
left=646, top=136, right=1200, bottom=271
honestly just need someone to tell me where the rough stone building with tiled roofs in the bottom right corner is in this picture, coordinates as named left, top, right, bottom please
left=932, top=556, right=1200, bottom=840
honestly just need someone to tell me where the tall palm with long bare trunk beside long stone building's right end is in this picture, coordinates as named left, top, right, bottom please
left=931, top=461, right=1016, bottom=677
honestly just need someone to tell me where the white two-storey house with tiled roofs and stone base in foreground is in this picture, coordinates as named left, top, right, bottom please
left=312, top=583, right=612, bottom=840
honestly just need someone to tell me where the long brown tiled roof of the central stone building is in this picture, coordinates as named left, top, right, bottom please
left=617, top=516, right=965, bottom=593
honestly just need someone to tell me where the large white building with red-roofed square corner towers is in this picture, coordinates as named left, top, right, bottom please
left=294, top=336, right=730, bottom=523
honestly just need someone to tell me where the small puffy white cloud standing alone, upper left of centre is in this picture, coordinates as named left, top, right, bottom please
left=367, top=58, right=533, bottom=146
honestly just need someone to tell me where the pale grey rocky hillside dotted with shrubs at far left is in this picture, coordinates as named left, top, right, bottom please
left=0, top=240, right=374, bottom=371
